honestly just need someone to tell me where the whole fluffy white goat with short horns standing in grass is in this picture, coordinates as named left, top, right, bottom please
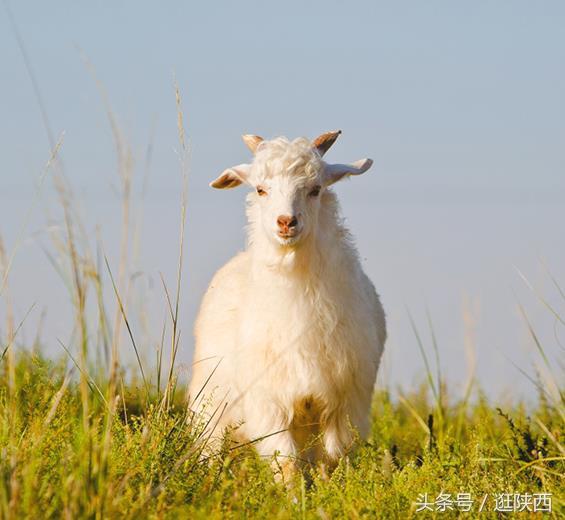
left=190, top=132, right=386, bottom=474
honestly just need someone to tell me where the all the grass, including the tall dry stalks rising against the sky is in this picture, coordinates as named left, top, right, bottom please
left=0, top=45, right=565, bottom=519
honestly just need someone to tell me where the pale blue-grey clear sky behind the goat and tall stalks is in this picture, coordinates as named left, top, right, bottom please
left=0, top=0, right=565, bottom=399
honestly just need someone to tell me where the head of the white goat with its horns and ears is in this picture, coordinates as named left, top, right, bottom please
left=211, top=132, right=372, bottom=247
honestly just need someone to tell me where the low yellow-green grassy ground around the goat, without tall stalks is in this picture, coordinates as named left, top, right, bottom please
left=0, top=353, right=565, bottom=518
